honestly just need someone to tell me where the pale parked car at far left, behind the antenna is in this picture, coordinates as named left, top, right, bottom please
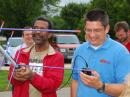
left=4, top=37, right=23, bottom=65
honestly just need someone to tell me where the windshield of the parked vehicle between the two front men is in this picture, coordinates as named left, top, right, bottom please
left=57, top=35, right=79, bottom=44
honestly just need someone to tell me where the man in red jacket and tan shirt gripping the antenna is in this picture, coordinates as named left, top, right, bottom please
left=9, top=17, right=64, bottom=97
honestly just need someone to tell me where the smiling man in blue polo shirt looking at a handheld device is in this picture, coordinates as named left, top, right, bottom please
left=71, top=9, right=130, bottom=97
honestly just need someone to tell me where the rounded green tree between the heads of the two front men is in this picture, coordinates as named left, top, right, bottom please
left=61, top=3, right=87, bottom=29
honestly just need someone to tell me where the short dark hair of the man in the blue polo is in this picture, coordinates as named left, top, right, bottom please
left=85, top=8, right=109, bottom=27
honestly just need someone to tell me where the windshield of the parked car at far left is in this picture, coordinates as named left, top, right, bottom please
left=9, top=38, right=23, bottom=47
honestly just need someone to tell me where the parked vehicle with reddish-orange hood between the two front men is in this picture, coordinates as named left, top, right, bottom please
left=54, top=34, right=80, bottom=59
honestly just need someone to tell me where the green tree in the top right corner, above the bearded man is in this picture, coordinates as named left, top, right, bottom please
left=90, top=0, right=130, bottom=38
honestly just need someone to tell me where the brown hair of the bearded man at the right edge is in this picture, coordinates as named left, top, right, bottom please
left=114, top=21, right=129, bottom=32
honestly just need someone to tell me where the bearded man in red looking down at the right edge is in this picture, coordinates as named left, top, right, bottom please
left=114, top=21, right=130, bottom=52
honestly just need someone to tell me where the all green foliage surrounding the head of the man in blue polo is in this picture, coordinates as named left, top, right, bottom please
left=61, top=0, right=130, bottom=40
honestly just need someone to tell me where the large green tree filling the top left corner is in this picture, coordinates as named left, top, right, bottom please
left=0, top=0, right=60, bottom=36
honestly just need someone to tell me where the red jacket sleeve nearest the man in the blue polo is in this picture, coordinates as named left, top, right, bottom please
left=31, top=54, right=64, bottom=93
